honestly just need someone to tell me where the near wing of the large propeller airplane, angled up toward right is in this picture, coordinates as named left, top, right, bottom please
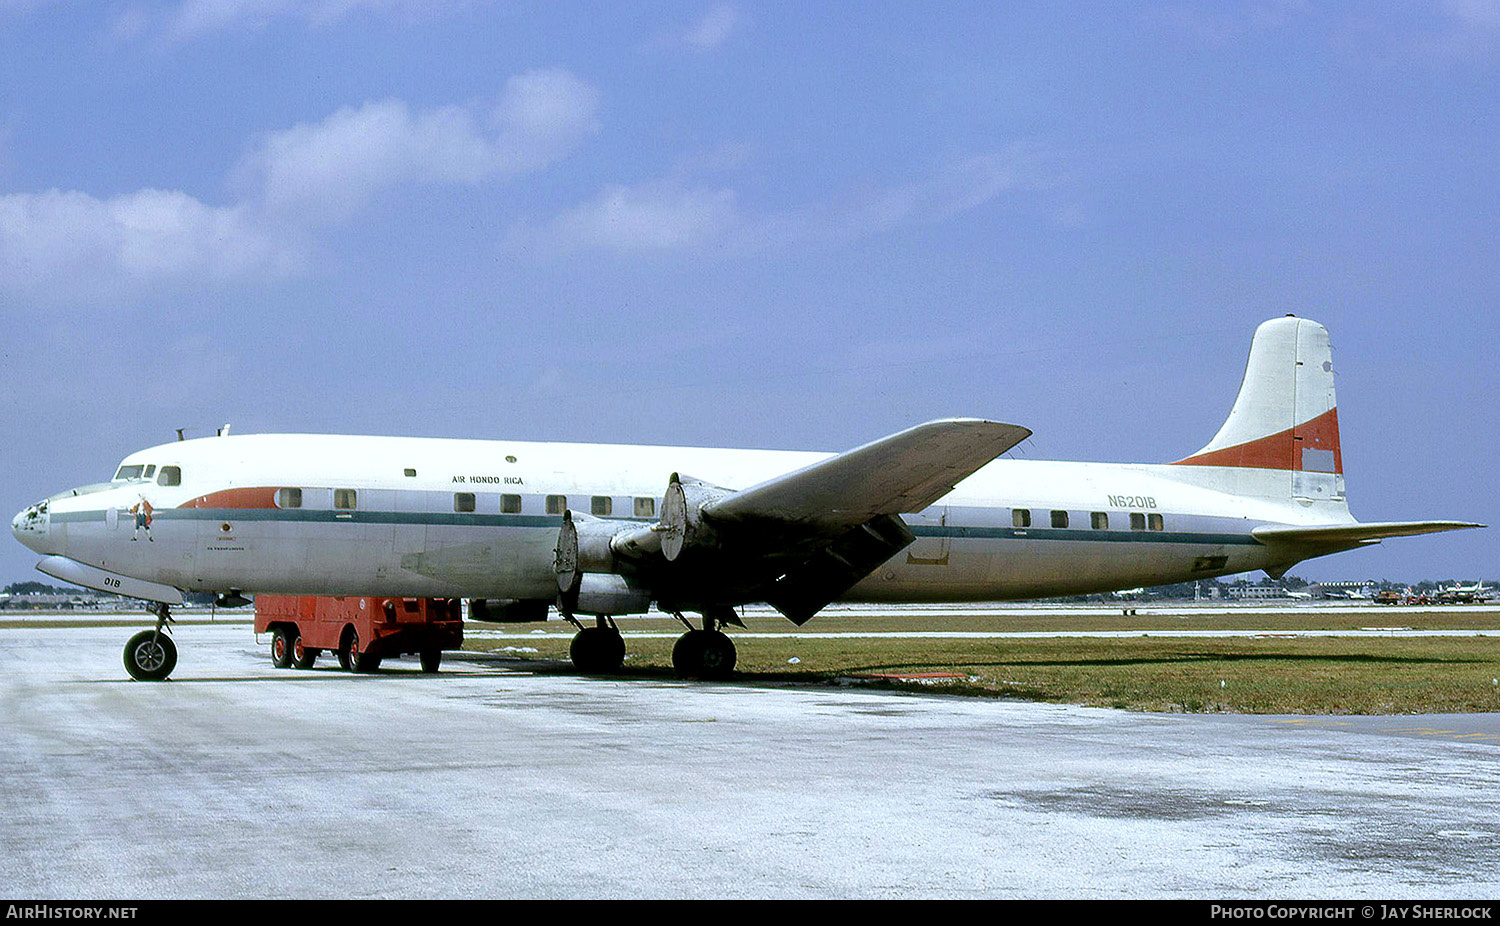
left=704, top=419, right=1031, bottom=525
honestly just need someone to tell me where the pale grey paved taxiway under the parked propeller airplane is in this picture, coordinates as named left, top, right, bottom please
left=0, top=624, right=1500, bottom=899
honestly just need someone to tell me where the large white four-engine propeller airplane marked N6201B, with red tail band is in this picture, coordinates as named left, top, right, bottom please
left=12, top=315, right=1484, bottom=678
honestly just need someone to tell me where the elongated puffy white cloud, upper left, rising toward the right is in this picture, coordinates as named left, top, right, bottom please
left=239, top=69, right=599, bottom=221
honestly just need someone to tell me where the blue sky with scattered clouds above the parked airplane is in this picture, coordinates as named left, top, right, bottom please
left=0, top=0, right=1500, bottom=582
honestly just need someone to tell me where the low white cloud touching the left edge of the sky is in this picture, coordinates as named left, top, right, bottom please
left=0, top=189, right=303, bottom=296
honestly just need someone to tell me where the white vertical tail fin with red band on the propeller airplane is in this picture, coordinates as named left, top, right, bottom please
left=1176, top=315, right=1344, bottom=503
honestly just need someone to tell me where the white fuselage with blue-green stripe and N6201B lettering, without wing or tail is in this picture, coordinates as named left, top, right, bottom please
left=12, top=435, right=1352, bottom=602
